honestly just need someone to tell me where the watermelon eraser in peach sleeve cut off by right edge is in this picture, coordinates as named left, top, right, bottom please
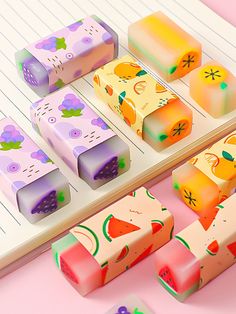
left=155, top=194, right=236, bottom=301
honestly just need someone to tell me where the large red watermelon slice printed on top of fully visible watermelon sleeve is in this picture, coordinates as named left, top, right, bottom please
left=102, top=215, right=140, bottom=242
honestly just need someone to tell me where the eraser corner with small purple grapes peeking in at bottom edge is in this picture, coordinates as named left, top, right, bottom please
left=106, top=294, right=154, bottom=314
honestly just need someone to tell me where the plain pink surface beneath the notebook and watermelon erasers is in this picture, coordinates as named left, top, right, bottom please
left=0, top=0, right=236, bottom=314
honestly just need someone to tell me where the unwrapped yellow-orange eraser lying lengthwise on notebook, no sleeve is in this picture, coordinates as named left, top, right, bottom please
left=128, top=11, right=202, bottom=82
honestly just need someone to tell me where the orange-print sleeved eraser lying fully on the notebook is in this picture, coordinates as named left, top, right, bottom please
left=94, top=55, right=192, bottom=150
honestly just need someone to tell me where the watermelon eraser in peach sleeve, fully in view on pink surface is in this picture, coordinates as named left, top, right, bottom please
left=52, top=187, right=174, bottom=296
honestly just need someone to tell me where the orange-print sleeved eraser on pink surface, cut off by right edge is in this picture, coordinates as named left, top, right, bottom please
left=172, top=131, right=236, bottom=215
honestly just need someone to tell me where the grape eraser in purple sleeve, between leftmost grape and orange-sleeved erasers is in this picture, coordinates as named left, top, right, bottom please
left=31, top=87, right=130, bottom=189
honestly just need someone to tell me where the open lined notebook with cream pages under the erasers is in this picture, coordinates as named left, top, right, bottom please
left=0, top=0, right=236, bottom=273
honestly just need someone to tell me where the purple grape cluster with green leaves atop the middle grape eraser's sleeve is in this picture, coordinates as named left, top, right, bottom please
left=58, top=94, right=85, bottom=118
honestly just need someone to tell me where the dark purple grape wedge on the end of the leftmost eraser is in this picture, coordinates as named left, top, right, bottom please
left=31, top=191, right=58, bottom=214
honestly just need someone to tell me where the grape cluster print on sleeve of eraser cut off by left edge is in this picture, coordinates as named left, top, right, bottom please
left=0, top=125, right=24, bottom=150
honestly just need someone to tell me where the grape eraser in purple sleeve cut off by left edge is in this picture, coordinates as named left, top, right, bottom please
left=0, top=118, right=70, bottom=223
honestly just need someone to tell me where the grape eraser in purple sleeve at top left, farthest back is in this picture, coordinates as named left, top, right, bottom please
left=16, top=15, right=118, bottom=97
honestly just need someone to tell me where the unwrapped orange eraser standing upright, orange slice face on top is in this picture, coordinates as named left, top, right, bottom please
left=190, top=61, right=236, bottom=118
